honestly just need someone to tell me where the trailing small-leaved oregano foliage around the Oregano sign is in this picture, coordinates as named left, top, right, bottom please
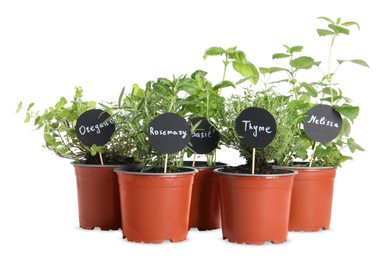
left=16, top=87, right=136, bottom=164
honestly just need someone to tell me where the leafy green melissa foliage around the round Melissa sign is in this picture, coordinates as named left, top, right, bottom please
left=273, top=17, right=369, bottom=167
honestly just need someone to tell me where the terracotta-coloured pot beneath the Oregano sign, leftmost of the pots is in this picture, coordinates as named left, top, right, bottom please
left=73, top=163, right=121, bottom=230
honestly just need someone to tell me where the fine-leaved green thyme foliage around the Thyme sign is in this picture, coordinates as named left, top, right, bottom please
left=216, top=88, right=298, bottom=172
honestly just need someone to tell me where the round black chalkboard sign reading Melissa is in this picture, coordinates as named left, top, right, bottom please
left=304, top=105, right=343, bottom=143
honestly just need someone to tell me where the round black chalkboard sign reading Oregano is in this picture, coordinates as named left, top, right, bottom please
left=75, top=109, right=116, bottom=146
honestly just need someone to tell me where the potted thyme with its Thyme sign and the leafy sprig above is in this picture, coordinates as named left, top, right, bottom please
left=208, top=47, right=297, bottom=244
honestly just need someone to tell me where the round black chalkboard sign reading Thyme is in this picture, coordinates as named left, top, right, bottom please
left=236, top=107, right=277, bottom=148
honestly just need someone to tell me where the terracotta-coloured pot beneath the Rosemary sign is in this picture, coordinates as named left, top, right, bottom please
left=115, top=167, right=197, bottom=243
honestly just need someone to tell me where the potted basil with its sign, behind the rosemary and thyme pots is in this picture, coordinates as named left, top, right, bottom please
left=179, top=70, right=232, bottom=231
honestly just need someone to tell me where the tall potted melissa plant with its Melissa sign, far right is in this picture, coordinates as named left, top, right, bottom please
left=273, top=17, right=369, bottom=231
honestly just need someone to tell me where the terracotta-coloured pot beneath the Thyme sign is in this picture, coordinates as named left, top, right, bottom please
left=215, top=169, right=297, bottom=244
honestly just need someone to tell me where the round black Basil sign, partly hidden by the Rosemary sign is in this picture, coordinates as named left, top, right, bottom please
left=189, top=117, right=220, bottom=154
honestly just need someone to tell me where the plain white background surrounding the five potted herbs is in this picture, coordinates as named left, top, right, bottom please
left=0, top=0, right=387, bottom=260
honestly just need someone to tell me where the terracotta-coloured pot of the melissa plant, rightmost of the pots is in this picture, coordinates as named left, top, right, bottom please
left=278, top=167, right=336, bottom=231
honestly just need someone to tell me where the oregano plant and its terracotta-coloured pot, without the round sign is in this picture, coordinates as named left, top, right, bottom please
left=17, top=87, right=133, bottom=230
